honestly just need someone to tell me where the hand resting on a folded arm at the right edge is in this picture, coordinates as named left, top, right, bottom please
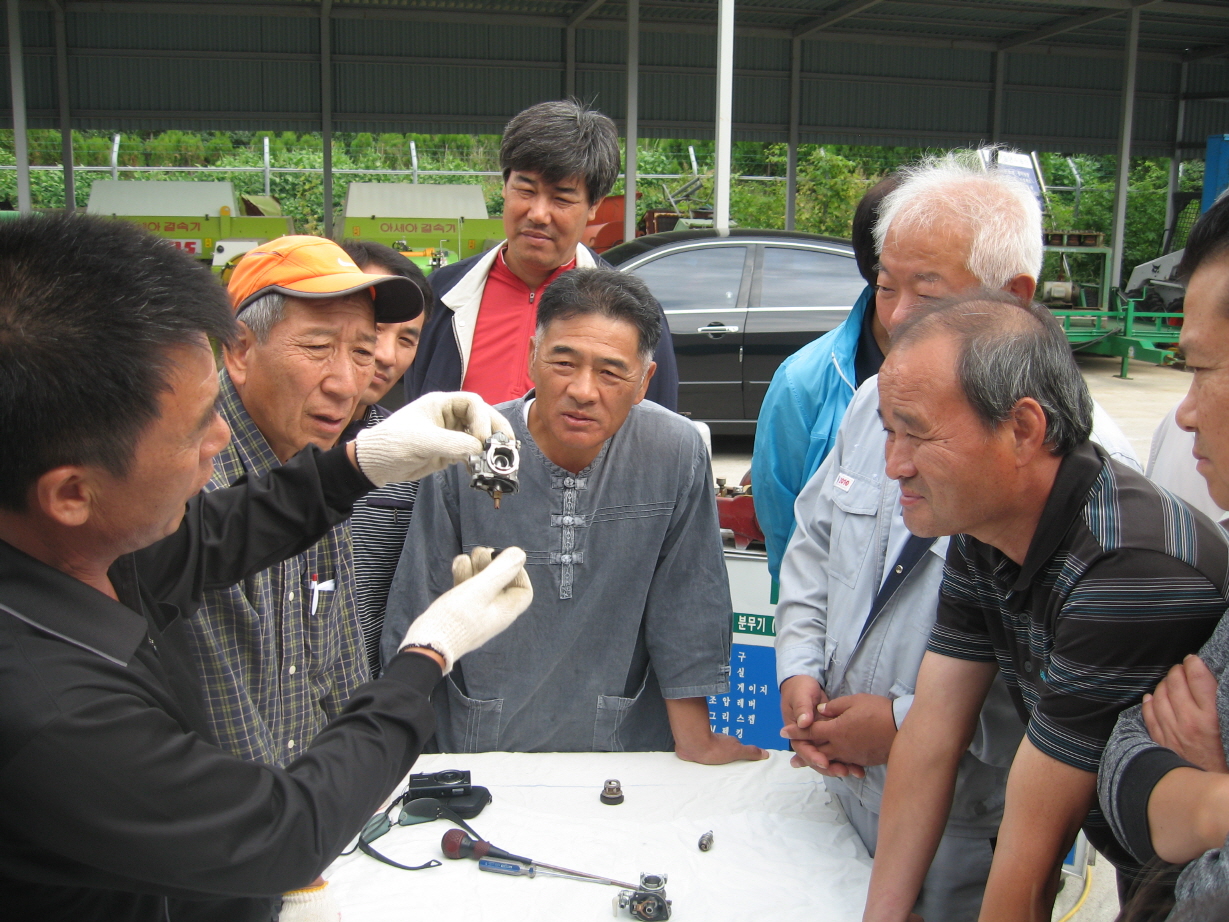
left=1143, top=654, right=1229, bottom=773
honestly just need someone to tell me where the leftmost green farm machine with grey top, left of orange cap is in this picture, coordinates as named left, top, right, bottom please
left=86, top=179, right=295, bottom=273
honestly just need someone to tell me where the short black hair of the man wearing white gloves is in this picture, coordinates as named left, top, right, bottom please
left=0, top=215, right=236, bottom=511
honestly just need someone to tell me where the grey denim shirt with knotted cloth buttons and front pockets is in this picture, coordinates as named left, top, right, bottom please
left=382, top=392, right=731, bottom=752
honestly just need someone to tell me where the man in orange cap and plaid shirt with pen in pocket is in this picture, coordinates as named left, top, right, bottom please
left=188, top=236, right=423, bottom=765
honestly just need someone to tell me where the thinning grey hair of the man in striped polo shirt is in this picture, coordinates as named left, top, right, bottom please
left=892, top=289, right=1093, bottom=456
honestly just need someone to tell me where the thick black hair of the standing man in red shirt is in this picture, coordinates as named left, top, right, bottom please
left=499, top=100, right=619, bottom=205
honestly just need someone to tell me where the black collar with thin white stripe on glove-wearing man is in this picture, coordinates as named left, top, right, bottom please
left=0, top=541, right=147, bottom=665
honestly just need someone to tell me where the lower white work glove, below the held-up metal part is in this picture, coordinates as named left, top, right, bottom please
left=399, top=547, right=533, bottom=675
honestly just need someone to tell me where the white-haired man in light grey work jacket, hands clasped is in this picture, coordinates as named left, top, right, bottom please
left=777, top=156, right=1138, bottom=922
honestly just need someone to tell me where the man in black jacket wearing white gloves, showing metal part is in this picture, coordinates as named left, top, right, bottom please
left=0, top=216, right=532, bottom=922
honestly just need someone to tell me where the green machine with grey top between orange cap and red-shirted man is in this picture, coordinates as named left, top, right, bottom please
left=339, top=182, right=504, bottom=273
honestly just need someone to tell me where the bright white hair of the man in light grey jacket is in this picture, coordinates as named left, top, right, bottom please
left=875, top=150, right=1042, bottom=288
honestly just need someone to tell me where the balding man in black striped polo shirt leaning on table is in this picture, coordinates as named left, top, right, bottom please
left=864, top=291, right=1229, bottom=922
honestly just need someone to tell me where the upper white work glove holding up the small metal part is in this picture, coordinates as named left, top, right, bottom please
left=354, top=391, right=516, bottom=487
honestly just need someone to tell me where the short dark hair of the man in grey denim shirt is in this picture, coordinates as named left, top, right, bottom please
left=537, top=269, right=661, bottom=363
